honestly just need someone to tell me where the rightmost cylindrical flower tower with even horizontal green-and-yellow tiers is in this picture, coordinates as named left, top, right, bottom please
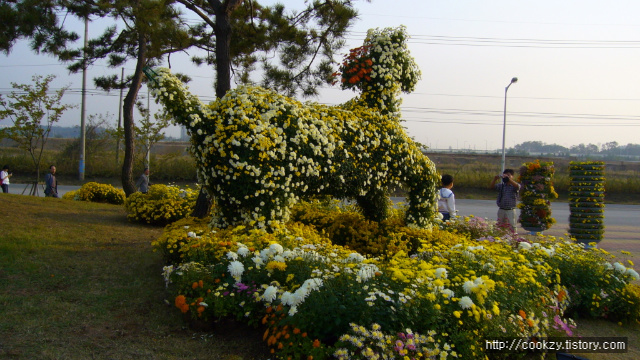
left=569, top=161, right=605, bottom=244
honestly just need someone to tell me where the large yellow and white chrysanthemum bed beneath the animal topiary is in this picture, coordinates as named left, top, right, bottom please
left=155, top=206, right=640, bottom=359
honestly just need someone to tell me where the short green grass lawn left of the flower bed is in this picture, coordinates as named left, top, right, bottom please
left=0, top=194, right=640, bottom=360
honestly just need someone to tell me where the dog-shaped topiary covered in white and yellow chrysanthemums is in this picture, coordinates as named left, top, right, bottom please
left=152, top=28, right=438, bottom=227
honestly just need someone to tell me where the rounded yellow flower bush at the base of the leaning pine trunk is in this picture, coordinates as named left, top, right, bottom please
left=124, top=184, right=198, bottom=225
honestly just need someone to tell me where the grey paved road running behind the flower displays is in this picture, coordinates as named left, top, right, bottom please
left=9, top=184, right=640, bottom=251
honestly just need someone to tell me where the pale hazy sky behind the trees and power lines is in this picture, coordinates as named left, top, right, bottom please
left=0, top=0, right=640, bottom=151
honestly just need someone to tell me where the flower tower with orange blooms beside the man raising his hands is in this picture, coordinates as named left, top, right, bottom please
left=518, top=160, right=558, bottom=231
